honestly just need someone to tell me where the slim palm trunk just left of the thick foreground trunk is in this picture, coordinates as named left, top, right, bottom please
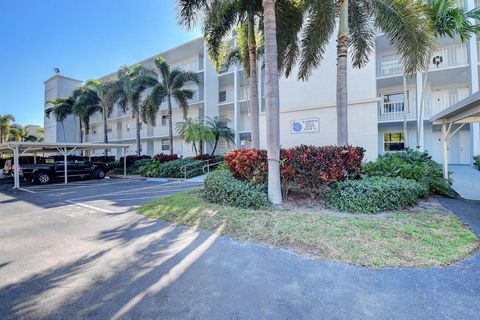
left=248, top=14, right=260, bottom=149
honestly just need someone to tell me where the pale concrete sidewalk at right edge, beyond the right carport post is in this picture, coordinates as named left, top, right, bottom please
left=448, top=165, right=480, bottom=200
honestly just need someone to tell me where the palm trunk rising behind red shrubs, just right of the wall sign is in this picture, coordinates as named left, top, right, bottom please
left=337, top=0, right=348, bottom=146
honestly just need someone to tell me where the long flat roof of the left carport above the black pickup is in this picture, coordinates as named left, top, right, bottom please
left=0, top=141, right=130, bottom=153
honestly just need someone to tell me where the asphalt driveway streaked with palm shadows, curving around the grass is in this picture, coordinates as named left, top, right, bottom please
left=0, top=180, right=480, bottom=319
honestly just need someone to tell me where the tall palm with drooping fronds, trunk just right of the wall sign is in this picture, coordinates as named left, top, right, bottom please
left=298, top=0, right=434, bottom=145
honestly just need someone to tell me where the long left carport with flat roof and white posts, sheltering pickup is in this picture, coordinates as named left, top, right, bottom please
left=0, top=141, right=130, bottom=189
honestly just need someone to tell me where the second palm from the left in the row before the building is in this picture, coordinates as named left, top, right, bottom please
left=72, top=86, right=102, bottom=142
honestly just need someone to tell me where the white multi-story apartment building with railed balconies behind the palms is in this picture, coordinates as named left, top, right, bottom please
left=45, top=0, right=480, bottom=164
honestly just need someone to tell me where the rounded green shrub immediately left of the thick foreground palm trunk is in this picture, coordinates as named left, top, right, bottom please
left=204, top=171, right=269, bottom=209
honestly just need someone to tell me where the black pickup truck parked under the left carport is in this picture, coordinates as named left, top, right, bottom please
left=14, top=156, right=109, bottom=184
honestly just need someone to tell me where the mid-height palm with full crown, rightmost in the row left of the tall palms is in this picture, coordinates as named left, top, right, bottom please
left=143, top=57, right=198, bottom=154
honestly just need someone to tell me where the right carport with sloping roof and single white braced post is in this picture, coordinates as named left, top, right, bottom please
left=431, top=92, right=480, bottom=179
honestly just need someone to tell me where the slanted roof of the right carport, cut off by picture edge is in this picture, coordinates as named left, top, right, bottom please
left=430, top=92, right=480, bottom=124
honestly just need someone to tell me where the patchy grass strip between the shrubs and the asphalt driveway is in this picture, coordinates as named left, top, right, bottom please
left=139, top=191, right=479, bottom=268
